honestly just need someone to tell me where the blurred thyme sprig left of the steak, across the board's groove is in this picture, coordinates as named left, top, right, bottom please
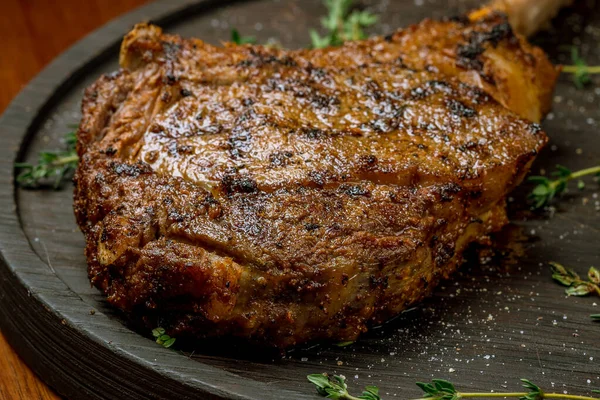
left=15, top=132, right=79, bottom=189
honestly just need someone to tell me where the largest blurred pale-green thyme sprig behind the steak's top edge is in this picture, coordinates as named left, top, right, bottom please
left=309, top=0, right=379, bottom=49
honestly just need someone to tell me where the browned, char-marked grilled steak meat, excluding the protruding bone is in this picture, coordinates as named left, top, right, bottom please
left=75, top=13, right=556, bottom=347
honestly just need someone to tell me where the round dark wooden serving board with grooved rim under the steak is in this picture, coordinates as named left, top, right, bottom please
left=0, top=0, right=600, bottom=399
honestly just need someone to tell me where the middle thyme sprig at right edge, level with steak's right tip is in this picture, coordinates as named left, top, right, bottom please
left=528, top=165, right=600, bottom=208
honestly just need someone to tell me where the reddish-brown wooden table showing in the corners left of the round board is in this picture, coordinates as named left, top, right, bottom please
left=0, top=0, right=148, bottom=400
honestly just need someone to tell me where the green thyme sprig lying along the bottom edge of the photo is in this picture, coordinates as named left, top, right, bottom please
left=307, top=374, right=600, bottom=400
